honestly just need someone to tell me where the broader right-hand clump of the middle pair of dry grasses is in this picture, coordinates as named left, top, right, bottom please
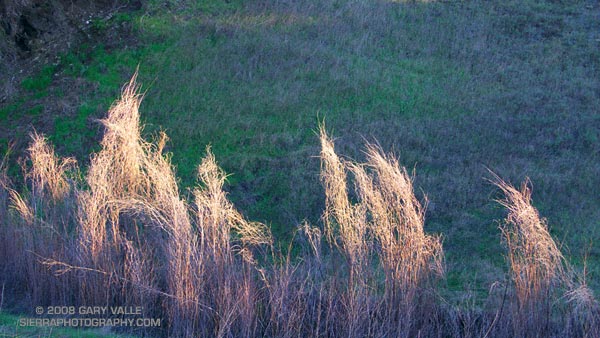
left=349, top=144, right=444, bottom=335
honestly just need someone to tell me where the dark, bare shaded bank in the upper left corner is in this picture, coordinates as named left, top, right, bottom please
left=0, top=0, right=142, bottom=103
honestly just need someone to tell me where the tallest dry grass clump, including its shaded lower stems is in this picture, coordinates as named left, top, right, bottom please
left=73, top=74, right=158, bottom=308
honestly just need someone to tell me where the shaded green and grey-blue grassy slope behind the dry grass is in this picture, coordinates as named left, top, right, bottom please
left=0, top=0, right=600, bottom=289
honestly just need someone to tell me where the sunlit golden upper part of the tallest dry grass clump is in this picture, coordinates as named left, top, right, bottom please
left=78, top=74, right=150, bottom=260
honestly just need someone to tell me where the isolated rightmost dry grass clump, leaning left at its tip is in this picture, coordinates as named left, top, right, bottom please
left=492, top=173, right=572, bottom=336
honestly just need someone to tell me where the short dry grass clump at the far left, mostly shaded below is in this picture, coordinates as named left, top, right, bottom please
left=1, top=133, right=77, bottom=304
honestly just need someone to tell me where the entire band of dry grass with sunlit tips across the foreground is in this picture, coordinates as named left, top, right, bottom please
left=0, top=76, right=600, bottom=337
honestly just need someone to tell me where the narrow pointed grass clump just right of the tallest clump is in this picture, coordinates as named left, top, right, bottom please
left=179, top=148, right=272, bottom=337
